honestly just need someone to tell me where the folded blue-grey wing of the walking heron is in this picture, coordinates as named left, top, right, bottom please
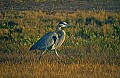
left=30, top=32, right=58, bottom=50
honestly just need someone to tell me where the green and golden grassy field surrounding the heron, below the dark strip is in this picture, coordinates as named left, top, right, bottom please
left=0, top=0, right=120, bottom=78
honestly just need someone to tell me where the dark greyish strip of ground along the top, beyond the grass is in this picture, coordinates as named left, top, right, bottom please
left=0, top=0, right=120, bottom=12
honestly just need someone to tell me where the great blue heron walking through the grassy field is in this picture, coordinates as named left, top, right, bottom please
left=30, top=22, right=70, bottom=60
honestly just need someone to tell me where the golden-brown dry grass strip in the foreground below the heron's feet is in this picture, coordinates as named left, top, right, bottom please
left=0, top=62, right=120, bottom=78
